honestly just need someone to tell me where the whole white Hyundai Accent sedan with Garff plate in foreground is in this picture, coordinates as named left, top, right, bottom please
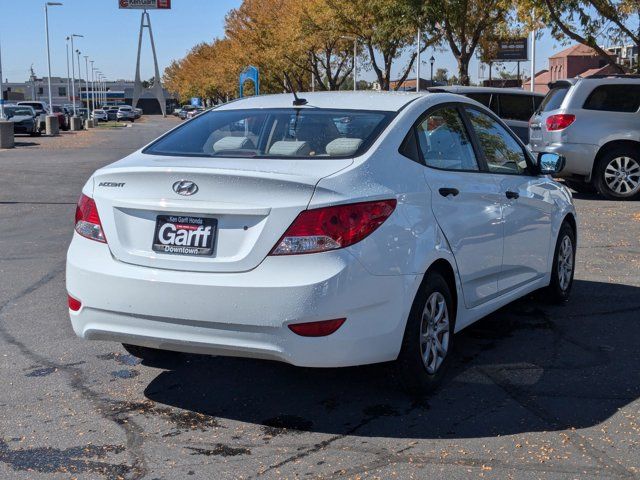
left=66, top=92, right=577, bottom=392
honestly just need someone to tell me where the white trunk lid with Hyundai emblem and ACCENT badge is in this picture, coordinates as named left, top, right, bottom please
left=94, top=153, right=353, bottom=272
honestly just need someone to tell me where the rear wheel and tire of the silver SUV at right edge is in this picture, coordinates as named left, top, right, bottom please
left=593, top=147, right=640, bottom=200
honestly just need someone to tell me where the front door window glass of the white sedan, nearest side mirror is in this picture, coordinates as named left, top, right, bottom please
left=467, top=108, right=527, bottom=174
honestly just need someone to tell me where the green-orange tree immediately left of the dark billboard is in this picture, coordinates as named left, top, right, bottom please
left=424, top=0, right=511, bottom=85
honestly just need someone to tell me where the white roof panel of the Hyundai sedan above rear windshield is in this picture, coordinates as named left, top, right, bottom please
left=216, top=90, right=423, bottom=112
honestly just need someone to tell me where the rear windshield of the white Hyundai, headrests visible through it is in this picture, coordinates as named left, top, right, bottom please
left=144, top=108, right=394, bottom=158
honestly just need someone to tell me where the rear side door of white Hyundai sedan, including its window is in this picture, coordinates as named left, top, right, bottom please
left=414, top=103, right=503, bottom=307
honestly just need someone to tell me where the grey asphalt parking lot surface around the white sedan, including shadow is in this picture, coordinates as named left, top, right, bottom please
left=0, top=117, right=640, bottom=480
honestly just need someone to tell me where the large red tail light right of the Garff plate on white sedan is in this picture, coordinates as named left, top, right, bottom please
left=271, top=199, right=396, bottom=255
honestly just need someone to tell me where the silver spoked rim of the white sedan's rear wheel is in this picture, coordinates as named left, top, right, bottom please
left=420, top=292, right=450, bottom=375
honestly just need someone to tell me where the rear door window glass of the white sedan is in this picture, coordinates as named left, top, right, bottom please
left=416, top=107, right=478, bottom=170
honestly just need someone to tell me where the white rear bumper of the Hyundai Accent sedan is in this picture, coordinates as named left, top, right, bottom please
left=67, top=234, right=420, bottom=367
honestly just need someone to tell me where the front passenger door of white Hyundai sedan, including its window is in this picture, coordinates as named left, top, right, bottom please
left=466, top=107, right=557, bottom=294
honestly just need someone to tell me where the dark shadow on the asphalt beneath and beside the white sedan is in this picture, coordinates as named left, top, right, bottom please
left=145, top=280, right=640, bottom=438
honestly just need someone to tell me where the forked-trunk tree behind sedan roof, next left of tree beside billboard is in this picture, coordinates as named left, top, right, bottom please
left=325, top=0, right=441, bottom=90
